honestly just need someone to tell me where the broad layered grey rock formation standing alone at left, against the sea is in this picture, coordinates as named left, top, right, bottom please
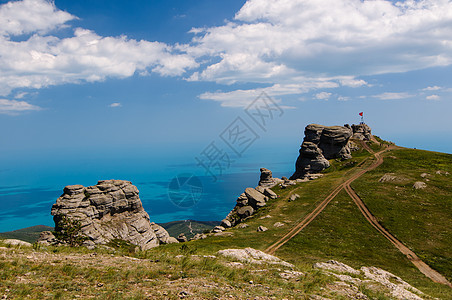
left=51, top=180, right=177, bottom=250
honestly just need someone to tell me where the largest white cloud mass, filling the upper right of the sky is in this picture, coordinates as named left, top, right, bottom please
left=179, top=0, right=452, bottom=96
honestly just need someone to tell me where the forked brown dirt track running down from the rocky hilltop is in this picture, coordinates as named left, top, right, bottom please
left=265, top=141, right=452, bottom=287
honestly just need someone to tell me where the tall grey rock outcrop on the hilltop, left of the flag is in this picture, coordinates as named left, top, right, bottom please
left=290, top=124, right=353, bottom=179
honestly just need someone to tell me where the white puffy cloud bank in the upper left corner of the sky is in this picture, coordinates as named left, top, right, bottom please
left=0, top=0, right=197, bottom=95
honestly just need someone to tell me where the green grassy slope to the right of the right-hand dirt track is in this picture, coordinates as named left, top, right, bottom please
left=352, top=149, right=452, bottom=281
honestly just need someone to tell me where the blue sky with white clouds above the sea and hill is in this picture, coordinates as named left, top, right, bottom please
left=0, top=0, right=452, bottom=157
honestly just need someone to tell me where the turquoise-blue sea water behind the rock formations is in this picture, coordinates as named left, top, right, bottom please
left=0, top=144, right=297, bottom=232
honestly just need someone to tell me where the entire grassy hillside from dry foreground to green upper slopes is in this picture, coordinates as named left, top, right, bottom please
left=0, top=144, right=452, bottom=299
